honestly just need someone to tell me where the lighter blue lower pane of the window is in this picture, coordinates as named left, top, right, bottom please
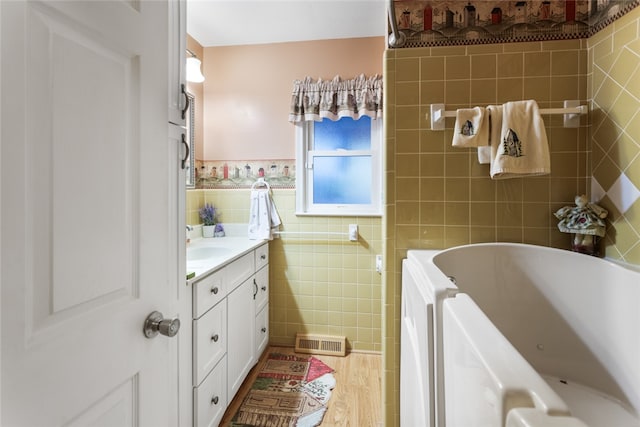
left=313, top=156, right=371, bottom=204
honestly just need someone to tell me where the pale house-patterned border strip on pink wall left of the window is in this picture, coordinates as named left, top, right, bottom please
left=196, top=159, right=296, bottom=189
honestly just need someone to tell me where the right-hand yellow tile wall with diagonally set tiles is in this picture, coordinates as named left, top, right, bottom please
left=588, top=8, right=640, bottom=264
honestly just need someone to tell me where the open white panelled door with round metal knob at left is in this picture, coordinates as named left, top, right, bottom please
left=0, top=0, right=178, bottom=427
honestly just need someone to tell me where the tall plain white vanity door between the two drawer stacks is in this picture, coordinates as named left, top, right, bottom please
left=227, top=278, right=255, bottom=399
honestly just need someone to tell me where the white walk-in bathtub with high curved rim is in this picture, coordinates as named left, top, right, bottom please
left=400, top=243, right=640, bottom=427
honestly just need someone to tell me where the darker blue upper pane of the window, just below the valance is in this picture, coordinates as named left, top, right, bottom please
left=313, top=116, right=371, bottom=150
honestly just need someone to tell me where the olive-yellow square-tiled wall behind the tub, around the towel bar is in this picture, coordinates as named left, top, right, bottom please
left=383, top=40, right=590, bottom=426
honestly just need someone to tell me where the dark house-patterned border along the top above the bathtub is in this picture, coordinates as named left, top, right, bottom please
left=394, top=0, right=640, bottom=48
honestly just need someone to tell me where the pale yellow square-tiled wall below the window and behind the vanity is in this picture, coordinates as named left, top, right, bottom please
left=187, top=189, right=382, bottom=352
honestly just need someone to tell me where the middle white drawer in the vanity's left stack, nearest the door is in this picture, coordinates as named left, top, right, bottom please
left=193, top=301, right=227, bottom=385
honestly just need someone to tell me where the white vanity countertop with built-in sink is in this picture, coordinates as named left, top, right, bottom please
left=187, top=224, right=267, bottom=283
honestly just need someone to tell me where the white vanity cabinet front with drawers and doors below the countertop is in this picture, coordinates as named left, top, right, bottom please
left=192, top=242, right=269, bottom=427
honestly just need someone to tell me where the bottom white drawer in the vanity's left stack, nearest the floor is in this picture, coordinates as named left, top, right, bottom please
left=193, top=356, right=227, bottom=427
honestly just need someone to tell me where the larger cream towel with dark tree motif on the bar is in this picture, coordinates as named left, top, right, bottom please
left=490, top=100, right=551, bottom=179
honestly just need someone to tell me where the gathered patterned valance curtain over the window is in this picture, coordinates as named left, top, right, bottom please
left=289, top=74, right=382, bottom=123
